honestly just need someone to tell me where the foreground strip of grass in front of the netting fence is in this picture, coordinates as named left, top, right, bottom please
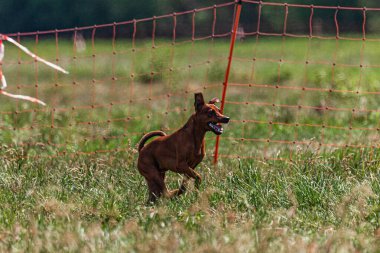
left=0, top=148, right=380, bottom=252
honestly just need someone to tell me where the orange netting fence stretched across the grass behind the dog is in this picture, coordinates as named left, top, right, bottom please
left=0, top=0, right=380, bottom=160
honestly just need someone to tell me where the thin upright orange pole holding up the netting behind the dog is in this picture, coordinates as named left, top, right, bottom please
left=214, top=0, right=242, bottom=164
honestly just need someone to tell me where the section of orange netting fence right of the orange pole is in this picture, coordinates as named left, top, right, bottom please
left=221, top=0, right=380, bottom=160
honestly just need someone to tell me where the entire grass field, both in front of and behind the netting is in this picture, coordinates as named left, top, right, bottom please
left=0, top=34, right=380, bottom=252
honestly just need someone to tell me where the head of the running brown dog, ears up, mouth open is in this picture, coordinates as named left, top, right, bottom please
left=194, top=93, right=230, bottom=135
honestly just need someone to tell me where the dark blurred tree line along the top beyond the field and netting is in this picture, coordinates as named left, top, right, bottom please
left=0, top=0, right=380, bottom=36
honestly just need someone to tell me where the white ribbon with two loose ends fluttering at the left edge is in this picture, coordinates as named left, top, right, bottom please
left=0, top=34, right=69, bottom=105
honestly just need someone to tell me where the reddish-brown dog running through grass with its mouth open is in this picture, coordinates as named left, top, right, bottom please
left=137, top=93, right=230, bottom=202
